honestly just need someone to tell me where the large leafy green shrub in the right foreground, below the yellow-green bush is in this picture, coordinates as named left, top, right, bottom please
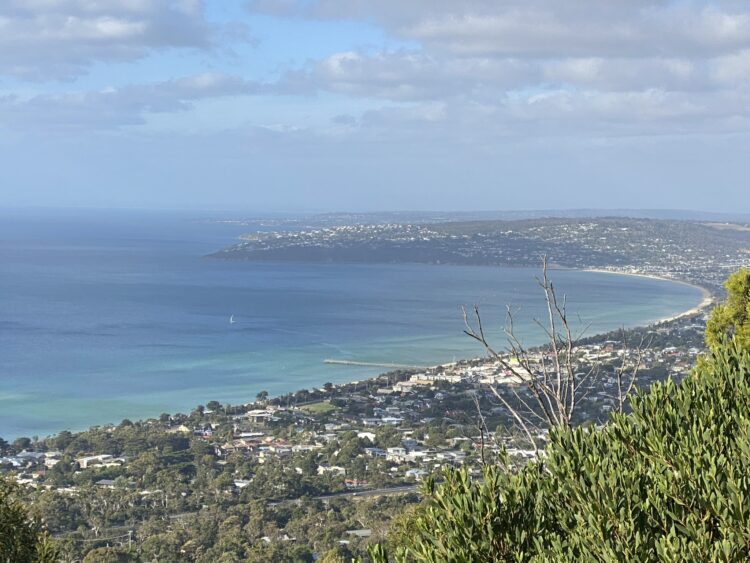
left=378, top=344, right=750, bottom=562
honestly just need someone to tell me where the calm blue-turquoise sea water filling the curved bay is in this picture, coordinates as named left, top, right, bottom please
left=0, top=211, right=701, bottom=438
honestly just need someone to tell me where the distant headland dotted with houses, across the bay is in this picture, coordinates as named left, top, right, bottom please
left=211, top=217, right=750, bottom=292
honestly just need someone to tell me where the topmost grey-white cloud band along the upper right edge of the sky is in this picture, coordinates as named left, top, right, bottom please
left=249, top=0, right=750, bottom=57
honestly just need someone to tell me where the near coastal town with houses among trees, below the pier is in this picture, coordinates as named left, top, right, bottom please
left=0, top=311, right=706, bottom=560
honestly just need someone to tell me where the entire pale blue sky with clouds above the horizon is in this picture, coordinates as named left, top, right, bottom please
left=0, top=0, right=750, bottom=213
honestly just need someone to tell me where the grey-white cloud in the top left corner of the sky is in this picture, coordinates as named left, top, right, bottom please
left=0, top=0, right=214, bottom=80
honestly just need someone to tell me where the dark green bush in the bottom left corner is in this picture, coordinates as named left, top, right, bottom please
left=0, top=478, right=57, bottom=563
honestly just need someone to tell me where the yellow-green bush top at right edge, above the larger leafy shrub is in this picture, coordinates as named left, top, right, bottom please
left=706, top=268, right=750, bottom=350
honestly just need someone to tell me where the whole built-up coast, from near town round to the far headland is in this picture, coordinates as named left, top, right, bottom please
left=0, top=218, right=750, bottom=563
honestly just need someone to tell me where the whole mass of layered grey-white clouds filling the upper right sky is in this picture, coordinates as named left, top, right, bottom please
left=249, top=0, right=750, bottom=142
